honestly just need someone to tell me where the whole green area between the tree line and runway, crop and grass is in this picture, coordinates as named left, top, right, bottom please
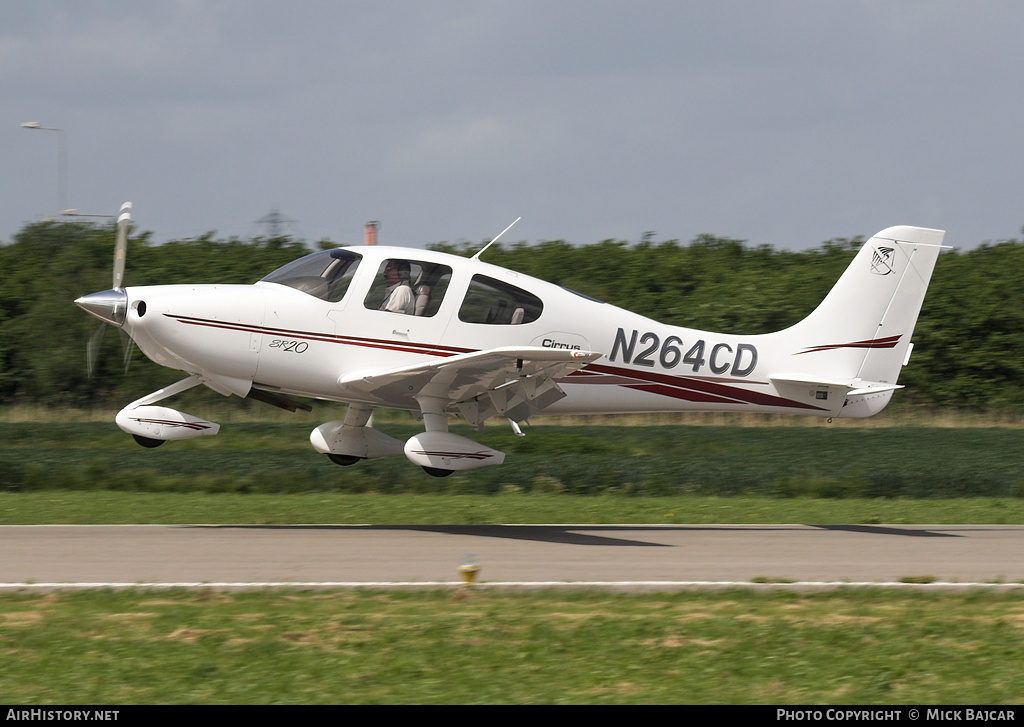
left=6, top=420, right=1024, bottom=524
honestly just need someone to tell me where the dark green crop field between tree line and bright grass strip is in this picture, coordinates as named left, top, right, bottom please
left=6, top=420, right=1024, bottom=500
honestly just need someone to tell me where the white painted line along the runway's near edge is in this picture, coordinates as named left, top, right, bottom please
left=0, top=581, right=1024, bottom=591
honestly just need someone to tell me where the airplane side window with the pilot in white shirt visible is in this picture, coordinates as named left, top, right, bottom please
left=364, top=258, right=452, bottom=317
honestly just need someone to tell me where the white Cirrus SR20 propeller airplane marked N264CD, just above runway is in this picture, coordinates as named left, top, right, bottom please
left=75, top=203, right=944, bottom=476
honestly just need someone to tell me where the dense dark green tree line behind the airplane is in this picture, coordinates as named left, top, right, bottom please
left=0, top=221, right=1024, bottom=411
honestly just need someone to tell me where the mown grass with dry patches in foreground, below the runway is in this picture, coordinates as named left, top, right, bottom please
left=0, top=590, right=1024, bottom=705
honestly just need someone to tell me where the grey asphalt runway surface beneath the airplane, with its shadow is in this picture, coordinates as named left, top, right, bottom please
left=0, top=524, right=1024, bottom=592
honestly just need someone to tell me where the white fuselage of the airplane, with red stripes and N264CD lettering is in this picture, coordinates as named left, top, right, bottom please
left=114, top=247, right=841, bottom=416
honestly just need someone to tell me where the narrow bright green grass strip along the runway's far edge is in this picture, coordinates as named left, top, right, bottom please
left=6, top=490, right=1024, bottom=525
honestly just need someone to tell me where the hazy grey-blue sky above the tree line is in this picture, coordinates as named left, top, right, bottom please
left=6, top=0, right=1024, bottom=250
